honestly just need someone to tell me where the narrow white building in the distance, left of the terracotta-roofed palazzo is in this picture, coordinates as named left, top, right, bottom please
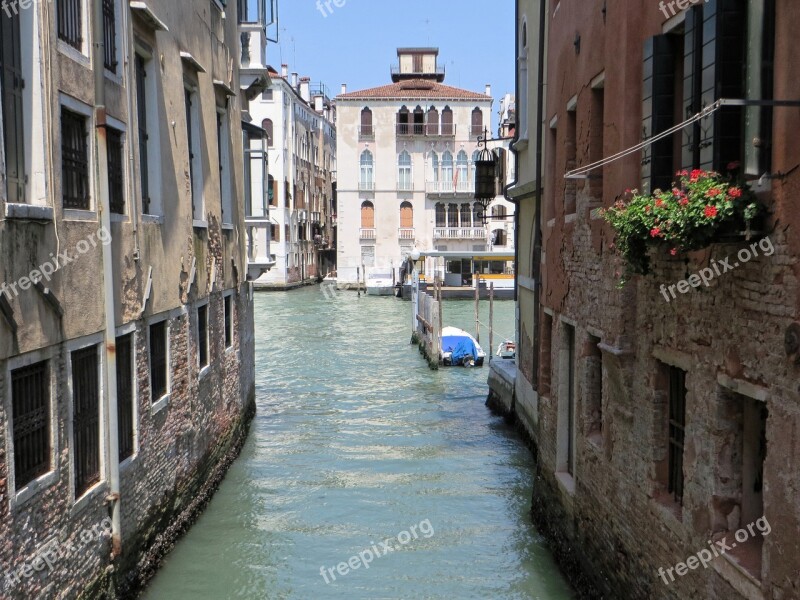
left=249, top=65, right=336, bottom=289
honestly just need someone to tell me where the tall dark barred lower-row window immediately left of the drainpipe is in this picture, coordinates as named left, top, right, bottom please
left=71, top=346, right=100, bottom=498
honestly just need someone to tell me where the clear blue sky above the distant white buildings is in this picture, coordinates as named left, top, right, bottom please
left=267, top=0, right=514, bottom=102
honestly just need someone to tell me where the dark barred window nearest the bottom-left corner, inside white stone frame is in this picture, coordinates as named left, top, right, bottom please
left=9, top=364, right=51, bottom=491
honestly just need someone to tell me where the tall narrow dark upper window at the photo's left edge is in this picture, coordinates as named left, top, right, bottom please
left=0, top=10, right=25, bottom=203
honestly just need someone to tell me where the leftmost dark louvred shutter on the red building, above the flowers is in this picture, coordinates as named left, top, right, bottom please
left=642, top=35, right=675, bottom=193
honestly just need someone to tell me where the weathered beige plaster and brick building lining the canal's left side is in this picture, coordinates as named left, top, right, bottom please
left=0, top=0, right=266, bottom=598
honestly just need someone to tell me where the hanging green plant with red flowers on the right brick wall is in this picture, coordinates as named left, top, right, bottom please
left=602, top=169, right=764, bottom=283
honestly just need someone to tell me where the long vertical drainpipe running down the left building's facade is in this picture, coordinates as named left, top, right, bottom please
left=92, top=0, right=122, bottom=560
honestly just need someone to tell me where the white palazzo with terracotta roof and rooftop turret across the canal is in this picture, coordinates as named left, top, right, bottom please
left=336, top=48, right=514, bottom=287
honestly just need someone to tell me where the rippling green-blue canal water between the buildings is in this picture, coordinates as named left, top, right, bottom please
left=144, top=288, right=573, bottom=600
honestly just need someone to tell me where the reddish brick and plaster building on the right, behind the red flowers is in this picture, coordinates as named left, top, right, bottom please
left=511, top=0, right=800, bottom=600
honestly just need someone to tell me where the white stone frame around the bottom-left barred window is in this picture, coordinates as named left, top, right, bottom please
left=4, top=346, right=60, bottom=514
